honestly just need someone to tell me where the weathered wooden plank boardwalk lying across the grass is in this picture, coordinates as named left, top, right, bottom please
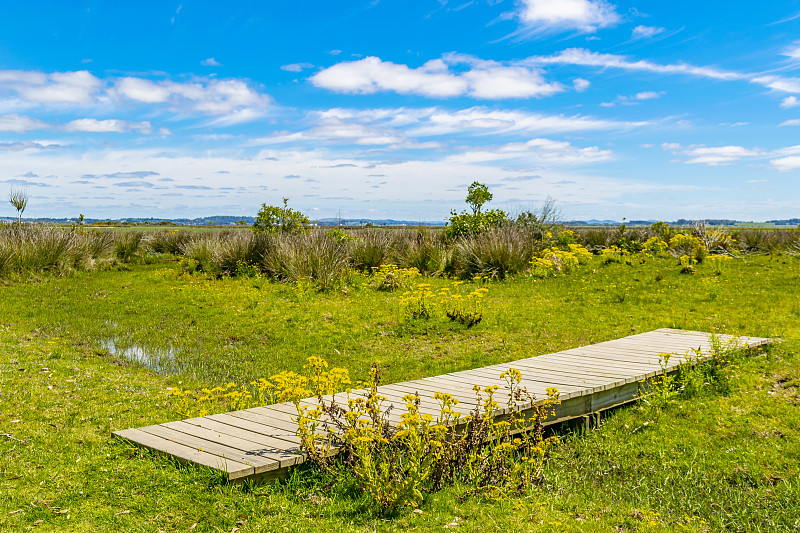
left=114, top=329, right=772, bottom=480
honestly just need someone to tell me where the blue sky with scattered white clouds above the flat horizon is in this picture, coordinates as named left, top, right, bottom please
left=0, top=0, right=800, bottom=220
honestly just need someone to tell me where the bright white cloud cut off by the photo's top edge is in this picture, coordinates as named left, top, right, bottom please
left=519, top=0, right=620, bottom=33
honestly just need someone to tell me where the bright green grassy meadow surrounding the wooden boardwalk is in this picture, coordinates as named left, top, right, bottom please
left=0, top=222, right=800, bottom=532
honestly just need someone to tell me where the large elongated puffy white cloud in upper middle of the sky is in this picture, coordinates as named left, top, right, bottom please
left=311, top=54, right=564, bottom=100
